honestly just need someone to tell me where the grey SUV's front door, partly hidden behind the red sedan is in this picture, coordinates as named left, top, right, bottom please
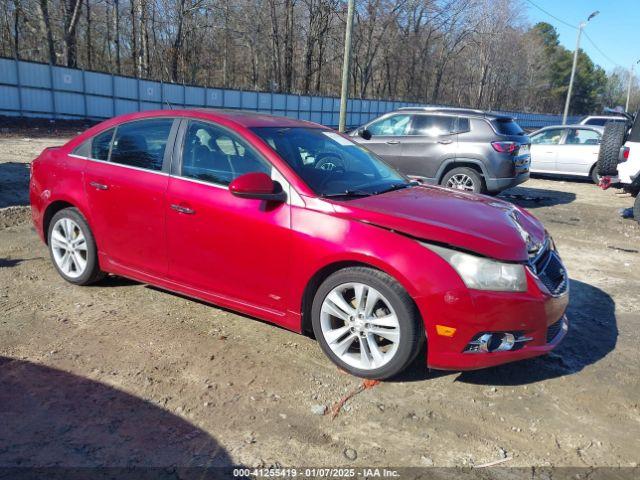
left=354, top=113, right=411, bottom=166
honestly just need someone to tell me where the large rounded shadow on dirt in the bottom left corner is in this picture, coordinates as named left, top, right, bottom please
left=0, top=356, right=232, bottom=472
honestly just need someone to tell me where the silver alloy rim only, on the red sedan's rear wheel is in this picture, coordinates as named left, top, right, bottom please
left=50, top=217, right=88, bottom=278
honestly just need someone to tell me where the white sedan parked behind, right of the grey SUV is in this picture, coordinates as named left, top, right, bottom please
left=529, top=125, right=604, bottom=183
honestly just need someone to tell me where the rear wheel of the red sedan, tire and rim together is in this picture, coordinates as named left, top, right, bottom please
left=47, top=208, right=105, bottom=285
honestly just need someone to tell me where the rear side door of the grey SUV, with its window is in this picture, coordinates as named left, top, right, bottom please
left=397, top=113, right=458, bottom=179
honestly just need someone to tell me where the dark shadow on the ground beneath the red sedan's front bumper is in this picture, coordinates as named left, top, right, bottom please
left=393, top=280, right=618, bottom=386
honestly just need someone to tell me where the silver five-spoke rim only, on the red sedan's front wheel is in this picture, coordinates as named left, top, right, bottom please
left=320, top=282, right=400, bottom=370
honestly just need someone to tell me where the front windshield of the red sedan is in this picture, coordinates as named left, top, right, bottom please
left=251, top=127, right=410, bottom=197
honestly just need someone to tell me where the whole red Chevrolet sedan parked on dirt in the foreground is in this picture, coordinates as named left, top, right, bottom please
left=30, top=110, right=569, bottom=378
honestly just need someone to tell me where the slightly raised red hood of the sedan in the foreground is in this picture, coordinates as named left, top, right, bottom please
left=333, top=185, right=546, bottom=262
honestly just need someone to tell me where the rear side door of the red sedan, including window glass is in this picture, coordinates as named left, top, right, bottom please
left=85, top=118, right=176, bottom=276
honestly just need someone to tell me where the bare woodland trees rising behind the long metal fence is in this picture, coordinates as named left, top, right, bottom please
left=0, top=0, right=640, bottom=114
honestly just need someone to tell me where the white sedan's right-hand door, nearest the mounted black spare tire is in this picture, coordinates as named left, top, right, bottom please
left=556, top=128, right=600, bottom=176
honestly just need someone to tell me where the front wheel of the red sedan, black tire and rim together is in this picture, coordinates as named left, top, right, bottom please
left=311, top=267, right=424, bottom=379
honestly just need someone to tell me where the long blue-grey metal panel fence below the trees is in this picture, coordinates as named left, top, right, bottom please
left=0, top=58, right=574, bottom=128
